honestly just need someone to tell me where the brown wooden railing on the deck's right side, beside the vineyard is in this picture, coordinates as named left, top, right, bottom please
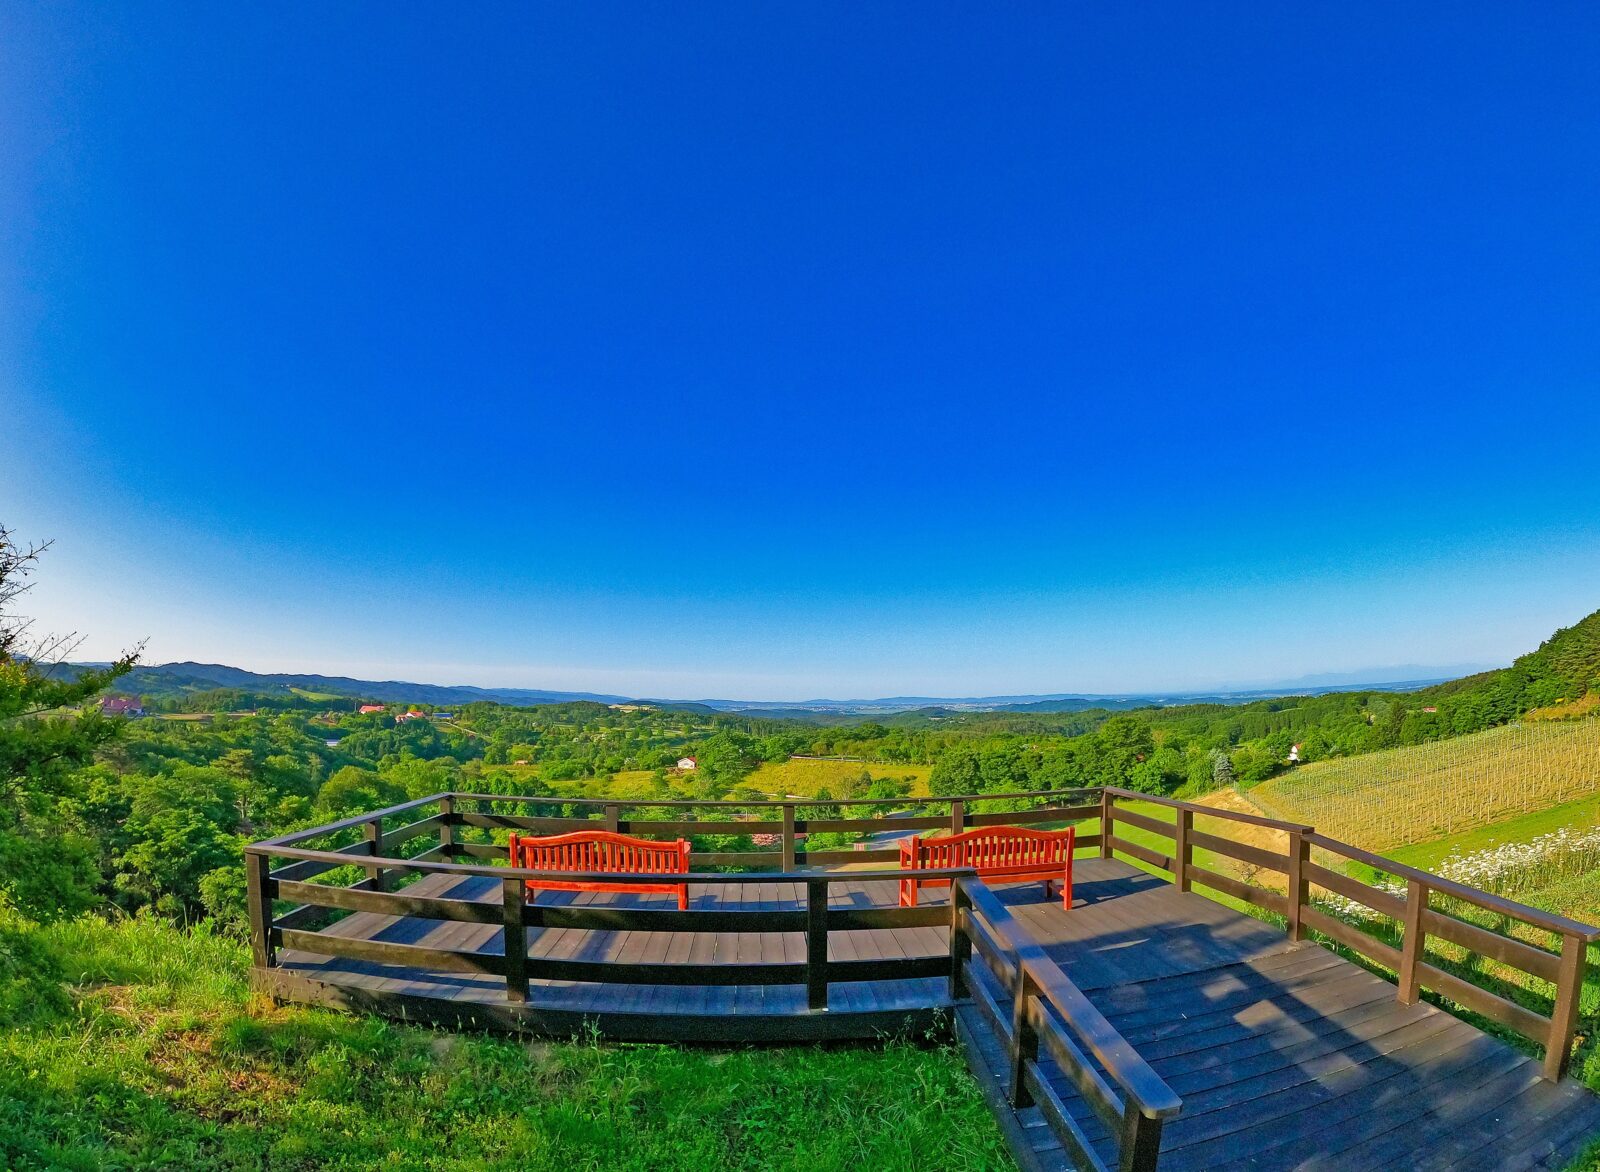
left=1101, top=788, right=1600, bottom=1081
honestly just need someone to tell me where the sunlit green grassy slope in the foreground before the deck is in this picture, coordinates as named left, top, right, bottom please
left=0, top=919, right=1011, bottom=1172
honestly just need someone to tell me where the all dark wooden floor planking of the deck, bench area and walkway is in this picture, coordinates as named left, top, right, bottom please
left=265, top=858, right=1600, bottom=1170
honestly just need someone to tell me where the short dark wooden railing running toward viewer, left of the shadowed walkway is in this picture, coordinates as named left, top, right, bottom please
left=950, top=879, right=1182, bottom=1172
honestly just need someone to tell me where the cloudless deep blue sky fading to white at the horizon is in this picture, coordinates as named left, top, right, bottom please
left=0, top=3, right=1600, bottom=698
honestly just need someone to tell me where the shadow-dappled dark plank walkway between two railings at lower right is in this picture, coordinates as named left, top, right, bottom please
left=957, top=860, right=1600, bottom=1172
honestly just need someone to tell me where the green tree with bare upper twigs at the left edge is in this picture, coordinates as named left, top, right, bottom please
left=0, top=525, right=139, bottom=917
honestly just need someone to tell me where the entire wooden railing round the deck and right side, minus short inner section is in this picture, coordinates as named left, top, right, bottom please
left=246, top=788, right=1600, bottom=1086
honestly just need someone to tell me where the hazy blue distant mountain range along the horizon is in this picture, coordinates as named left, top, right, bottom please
left=67, top=663, right=1472, bottom=719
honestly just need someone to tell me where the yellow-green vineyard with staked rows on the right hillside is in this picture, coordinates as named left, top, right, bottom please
left=1248, top=719, right=1600, bottom=850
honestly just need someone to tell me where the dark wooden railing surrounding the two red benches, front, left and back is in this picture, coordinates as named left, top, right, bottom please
left=245, top=791, right=1099, bottom=1009
